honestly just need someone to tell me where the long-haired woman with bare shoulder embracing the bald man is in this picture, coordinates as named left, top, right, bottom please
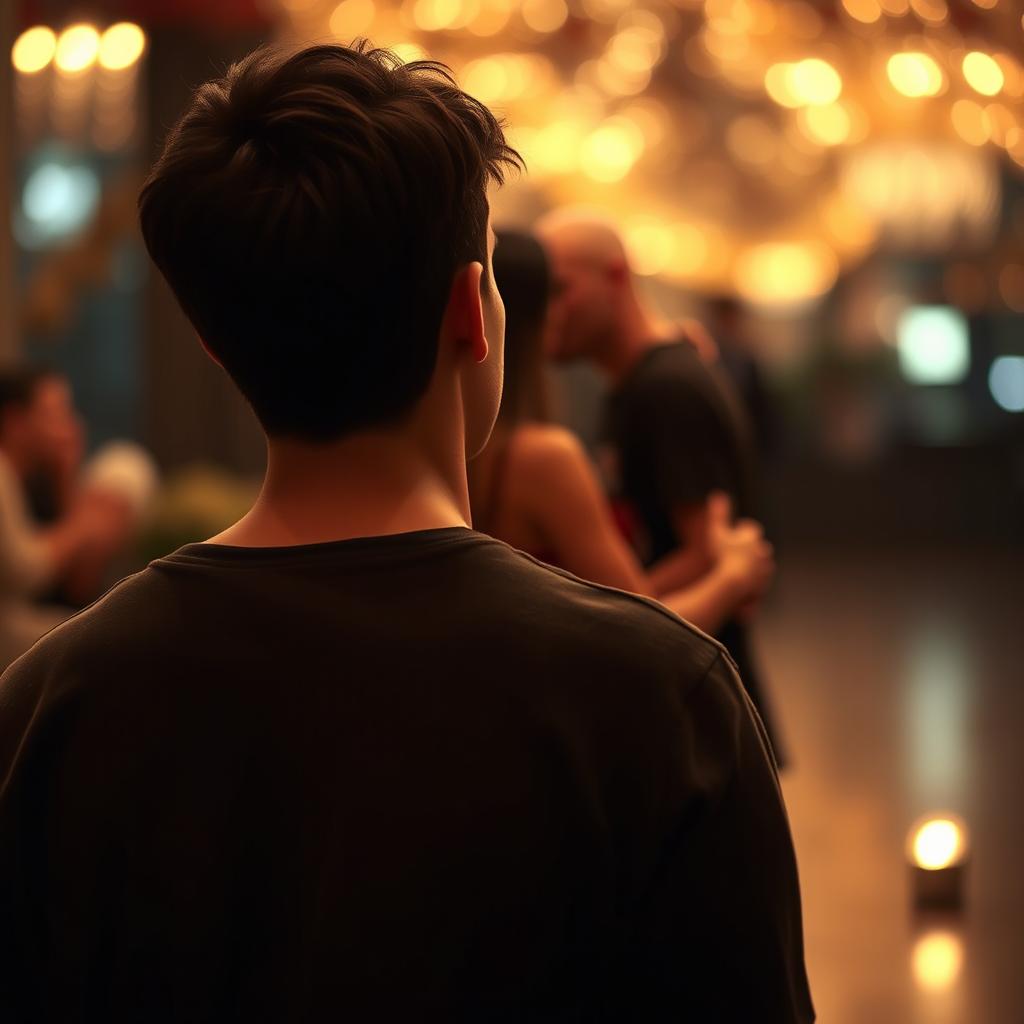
left=469, top=231, right=773, bottom=633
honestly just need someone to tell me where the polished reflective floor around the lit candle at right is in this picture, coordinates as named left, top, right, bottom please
left=759, top=548, right=1024, bottom=1024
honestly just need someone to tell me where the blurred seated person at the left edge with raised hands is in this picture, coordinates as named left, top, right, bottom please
left=0, top=368, right=142, bottom=666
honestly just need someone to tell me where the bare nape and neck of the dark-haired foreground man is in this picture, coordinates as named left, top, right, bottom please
left=209, top=432, right=470, bottom=548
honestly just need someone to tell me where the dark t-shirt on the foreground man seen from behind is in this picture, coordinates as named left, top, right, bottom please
left=0, top=528, right=813, bottom=1022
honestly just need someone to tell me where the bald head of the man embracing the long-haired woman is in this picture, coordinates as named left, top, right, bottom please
left=536, top=208, right=635, bottom=362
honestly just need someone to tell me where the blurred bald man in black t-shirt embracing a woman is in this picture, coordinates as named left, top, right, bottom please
left=537, top=209, right=781, bottom=761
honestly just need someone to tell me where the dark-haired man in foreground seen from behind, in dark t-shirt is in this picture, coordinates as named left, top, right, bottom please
left=0, top=43, right=813, bottom=1024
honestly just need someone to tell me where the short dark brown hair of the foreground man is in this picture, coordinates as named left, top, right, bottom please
left=139, top=42, right=518, bottom=441
